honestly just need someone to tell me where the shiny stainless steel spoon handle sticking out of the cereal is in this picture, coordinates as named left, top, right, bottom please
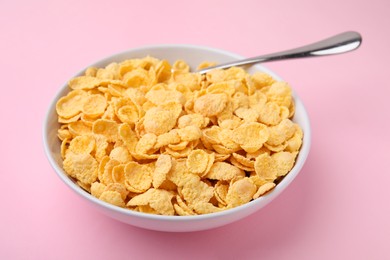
left=197, top=31, right=362, bottom=74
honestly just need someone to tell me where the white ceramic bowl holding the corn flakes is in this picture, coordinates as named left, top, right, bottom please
left=43, top=45, right=311, bottom=232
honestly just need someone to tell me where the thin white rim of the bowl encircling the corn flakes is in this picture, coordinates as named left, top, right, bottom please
left=42, top=44, right=311, bottom=222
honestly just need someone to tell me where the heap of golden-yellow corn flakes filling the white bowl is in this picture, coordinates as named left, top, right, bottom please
left=56, top=56, right=303, bottom=216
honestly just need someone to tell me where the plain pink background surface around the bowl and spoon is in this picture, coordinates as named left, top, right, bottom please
left=0, top=0, right=390, bottom=259
